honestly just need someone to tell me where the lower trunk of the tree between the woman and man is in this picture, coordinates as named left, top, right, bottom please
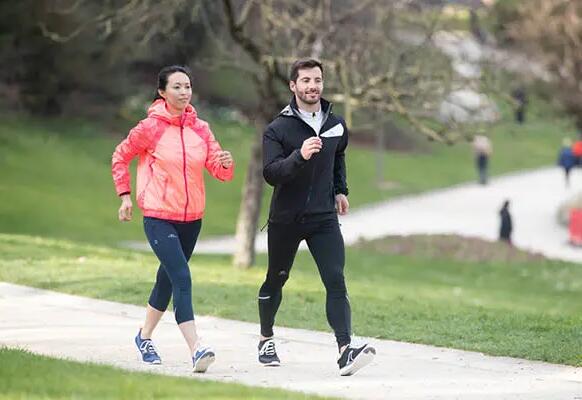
left=233, top=117, right=265, bottom=269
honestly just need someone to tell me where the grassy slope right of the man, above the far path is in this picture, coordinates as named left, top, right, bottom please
left=348, top=96, right=576, bottom=206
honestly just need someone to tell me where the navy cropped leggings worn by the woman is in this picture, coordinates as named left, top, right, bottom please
left=143, top=217, right=202, bottom=324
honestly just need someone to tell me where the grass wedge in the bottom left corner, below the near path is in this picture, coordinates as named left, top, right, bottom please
left=0, top=348, right=322, bottom=400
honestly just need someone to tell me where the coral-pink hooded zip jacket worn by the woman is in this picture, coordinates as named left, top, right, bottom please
left=111, top=99, right=234, bottom=222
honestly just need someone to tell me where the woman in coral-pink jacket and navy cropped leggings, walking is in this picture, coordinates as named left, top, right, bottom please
left=112, top=66, right=234, bottom=372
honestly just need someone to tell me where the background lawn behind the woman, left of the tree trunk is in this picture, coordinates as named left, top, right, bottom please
left=0, top=115, right=262, bottom=245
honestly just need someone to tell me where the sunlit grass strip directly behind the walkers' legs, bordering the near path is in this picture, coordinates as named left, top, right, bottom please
left=0, top=234, right=582, bottom=366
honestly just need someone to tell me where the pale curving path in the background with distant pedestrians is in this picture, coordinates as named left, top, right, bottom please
left=130, top=167, right=582, bottom=262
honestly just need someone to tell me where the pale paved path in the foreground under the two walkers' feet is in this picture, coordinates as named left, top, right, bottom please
left=0, top=282, right=582, bottom=400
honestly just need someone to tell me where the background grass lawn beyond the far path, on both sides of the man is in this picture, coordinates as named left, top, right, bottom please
left=0, top=94, right=574, bottom=245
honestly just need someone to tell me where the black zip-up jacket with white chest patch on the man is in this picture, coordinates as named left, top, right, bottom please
left=263, top=97, right=348, bottom=223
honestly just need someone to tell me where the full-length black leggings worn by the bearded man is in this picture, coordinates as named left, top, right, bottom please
left=259, top=219, right=351, bottom=347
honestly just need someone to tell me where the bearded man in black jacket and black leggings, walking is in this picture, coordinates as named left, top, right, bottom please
left=259, top=59, right=376, bottom=375
